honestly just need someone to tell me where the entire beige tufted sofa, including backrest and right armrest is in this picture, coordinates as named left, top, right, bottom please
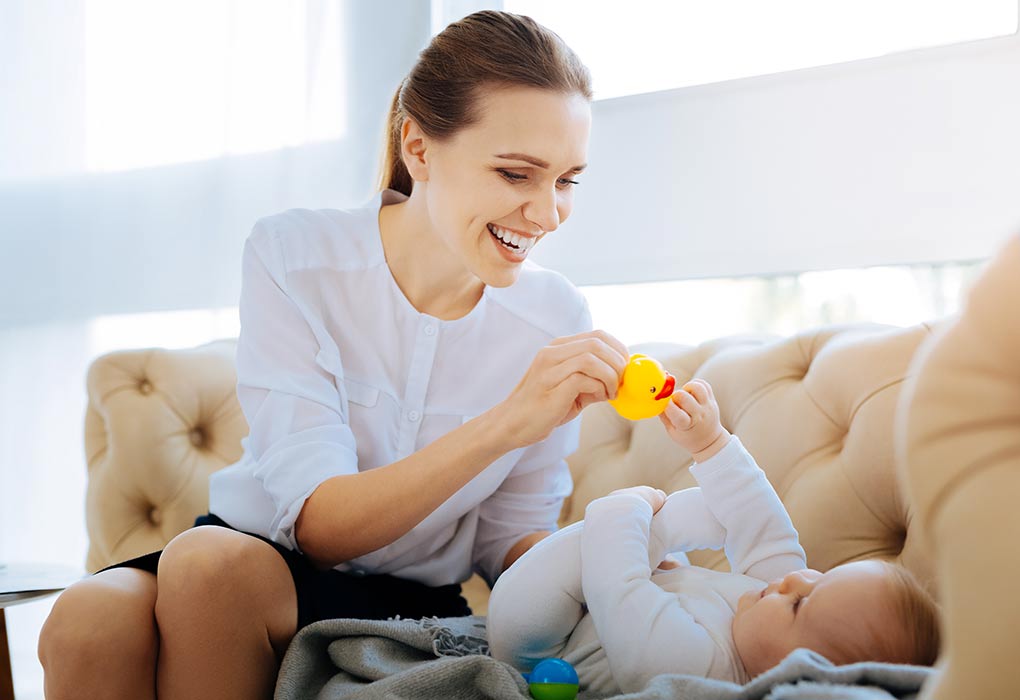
left=85, top=238, right=1020, bottom=700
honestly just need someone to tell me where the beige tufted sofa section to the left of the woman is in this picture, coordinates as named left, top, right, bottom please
left=85, top=340, right=248, bottom=571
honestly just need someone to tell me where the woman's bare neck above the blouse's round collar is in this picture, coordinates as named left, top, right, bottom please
left=378, top=197, right=485, bottom=320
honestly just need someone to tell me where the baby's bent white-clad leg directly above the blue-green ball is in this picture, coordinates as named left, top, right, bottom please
left=488, top=522, right=584, bottom=671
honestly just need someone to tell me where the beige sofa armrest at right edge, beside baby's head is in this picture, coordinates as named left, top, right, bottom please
left=899, top=237, right=1020, bottom=699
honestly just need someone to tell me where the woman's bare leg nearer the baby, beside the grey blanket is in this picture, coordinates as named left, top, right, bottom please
left=150, top=527, right=298, bottom=700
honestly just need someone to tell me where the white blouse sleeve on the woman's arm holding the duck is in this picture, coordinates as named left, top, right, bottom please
left=237, top=221, right=358, bottom=549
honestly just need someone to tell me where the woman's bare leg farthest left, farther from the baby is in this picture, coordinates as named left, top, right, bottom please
left=39, top=568, right=159, bottom=700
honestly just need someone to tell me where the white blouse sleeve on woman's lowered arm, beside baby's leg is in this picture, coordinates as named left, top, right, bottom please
left=472, top=418, right=580, bottom=586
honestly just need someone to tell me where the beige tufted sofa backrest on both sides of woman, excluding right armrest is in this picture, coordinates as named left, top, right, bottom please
left=86, top=326, right=931, bottom=612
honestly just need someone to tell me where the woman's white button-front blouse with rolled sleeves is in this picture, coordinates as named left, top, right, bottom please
left=209, top=190, right=592, bottom=586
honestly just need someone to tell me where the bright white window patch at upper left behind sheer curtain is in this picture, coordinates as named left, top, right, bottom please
left=83, top=0, right=345, bottom=171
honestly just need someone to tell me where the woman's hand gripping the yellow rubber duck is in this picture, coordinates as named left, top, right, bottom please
left=494, top=331, right=629, bottom=447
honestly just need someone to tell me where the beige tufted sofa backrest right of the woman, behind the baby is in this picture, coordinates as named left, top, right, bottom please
left=563, top=326, right=934, bottom=590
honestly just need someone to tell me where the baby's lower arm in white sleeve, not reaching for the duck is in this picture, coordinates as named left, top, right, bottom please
left=581, top=493, right=716, bottom=693
